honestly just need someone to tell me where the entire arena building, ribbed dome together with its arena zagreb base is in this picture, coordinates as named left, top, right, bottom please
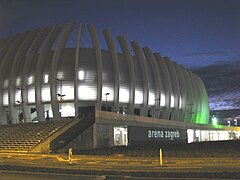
left=0, top=22, right=239, bottom=152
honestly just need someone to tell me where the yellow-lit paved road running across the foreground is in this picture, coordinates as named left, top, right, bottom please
left=0, top=153, right=240, bottom=180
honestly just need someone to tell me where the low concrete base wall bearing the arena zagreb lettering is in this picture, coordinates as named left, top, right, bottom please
left=55, top=110, right=239, bottom=152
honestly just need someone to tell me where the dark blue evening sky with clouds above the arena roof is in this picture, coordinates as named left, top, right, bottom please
left=0, top=0, right=240, bottom=109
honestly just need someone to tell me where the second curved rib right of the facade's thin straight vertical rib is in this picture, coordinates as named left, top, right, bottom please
left=103, top=29, right=119, bottom=112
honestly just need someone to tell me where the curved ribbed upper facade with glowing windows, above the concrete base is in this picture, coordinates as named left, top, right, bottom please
left=0, top=22, right=209, bottom=124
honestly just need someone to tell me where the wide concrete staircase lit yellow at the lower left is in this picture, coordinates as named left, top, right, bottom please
left=0, top=119, right=74, bottom=152
